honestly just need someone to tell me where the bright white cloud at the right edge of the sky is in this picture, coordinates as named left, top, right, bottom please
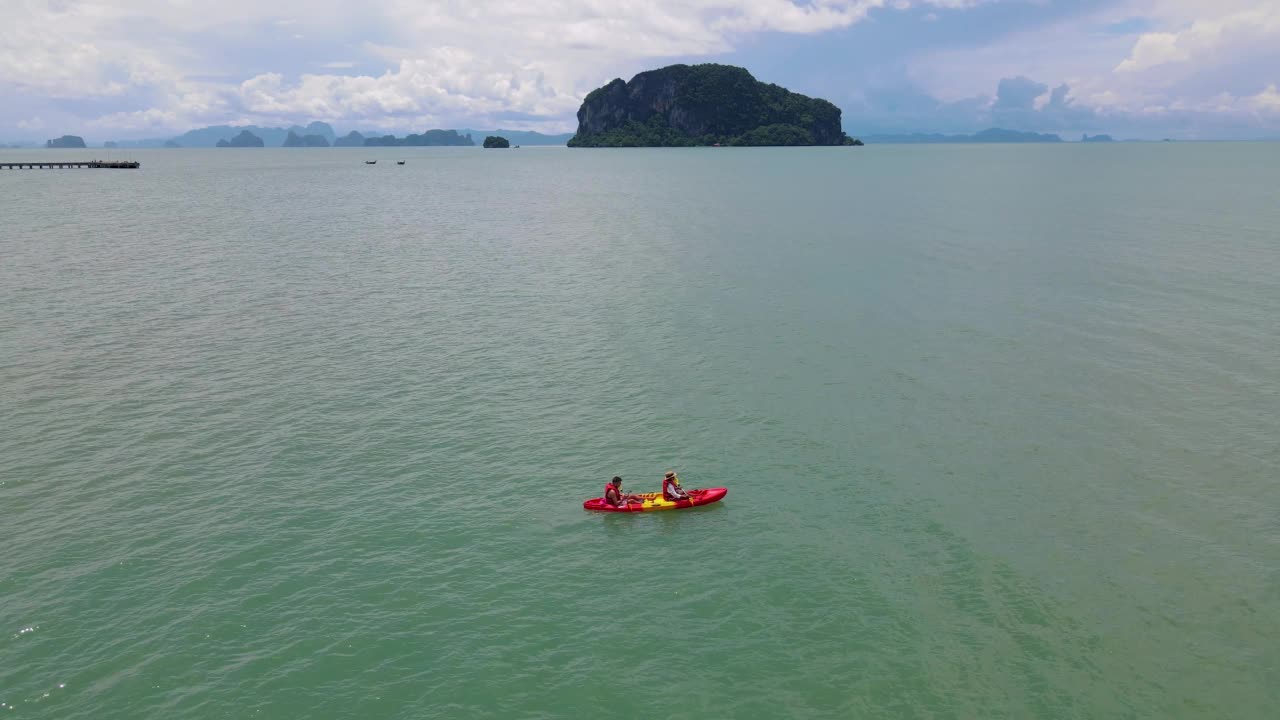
left=909, top=0, right=1280, bottom=137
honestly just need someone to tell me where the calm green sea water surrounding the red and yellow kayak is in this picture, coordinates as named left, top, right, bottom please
left=0, top=143, right=1280, bottom=720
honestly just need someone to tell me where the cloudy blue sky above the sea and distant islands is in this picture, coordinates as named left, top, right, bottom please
left=0, top=0, right=1280, bottom=140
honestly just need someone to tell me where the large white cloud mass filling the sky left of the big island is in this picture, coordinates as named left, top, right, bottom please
left=0, top=0, right=978, bottom=135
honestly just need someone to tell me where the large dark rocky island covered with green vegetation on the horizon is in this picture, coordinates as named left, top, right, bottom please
left=568, top=63, right=854, bottom=147
